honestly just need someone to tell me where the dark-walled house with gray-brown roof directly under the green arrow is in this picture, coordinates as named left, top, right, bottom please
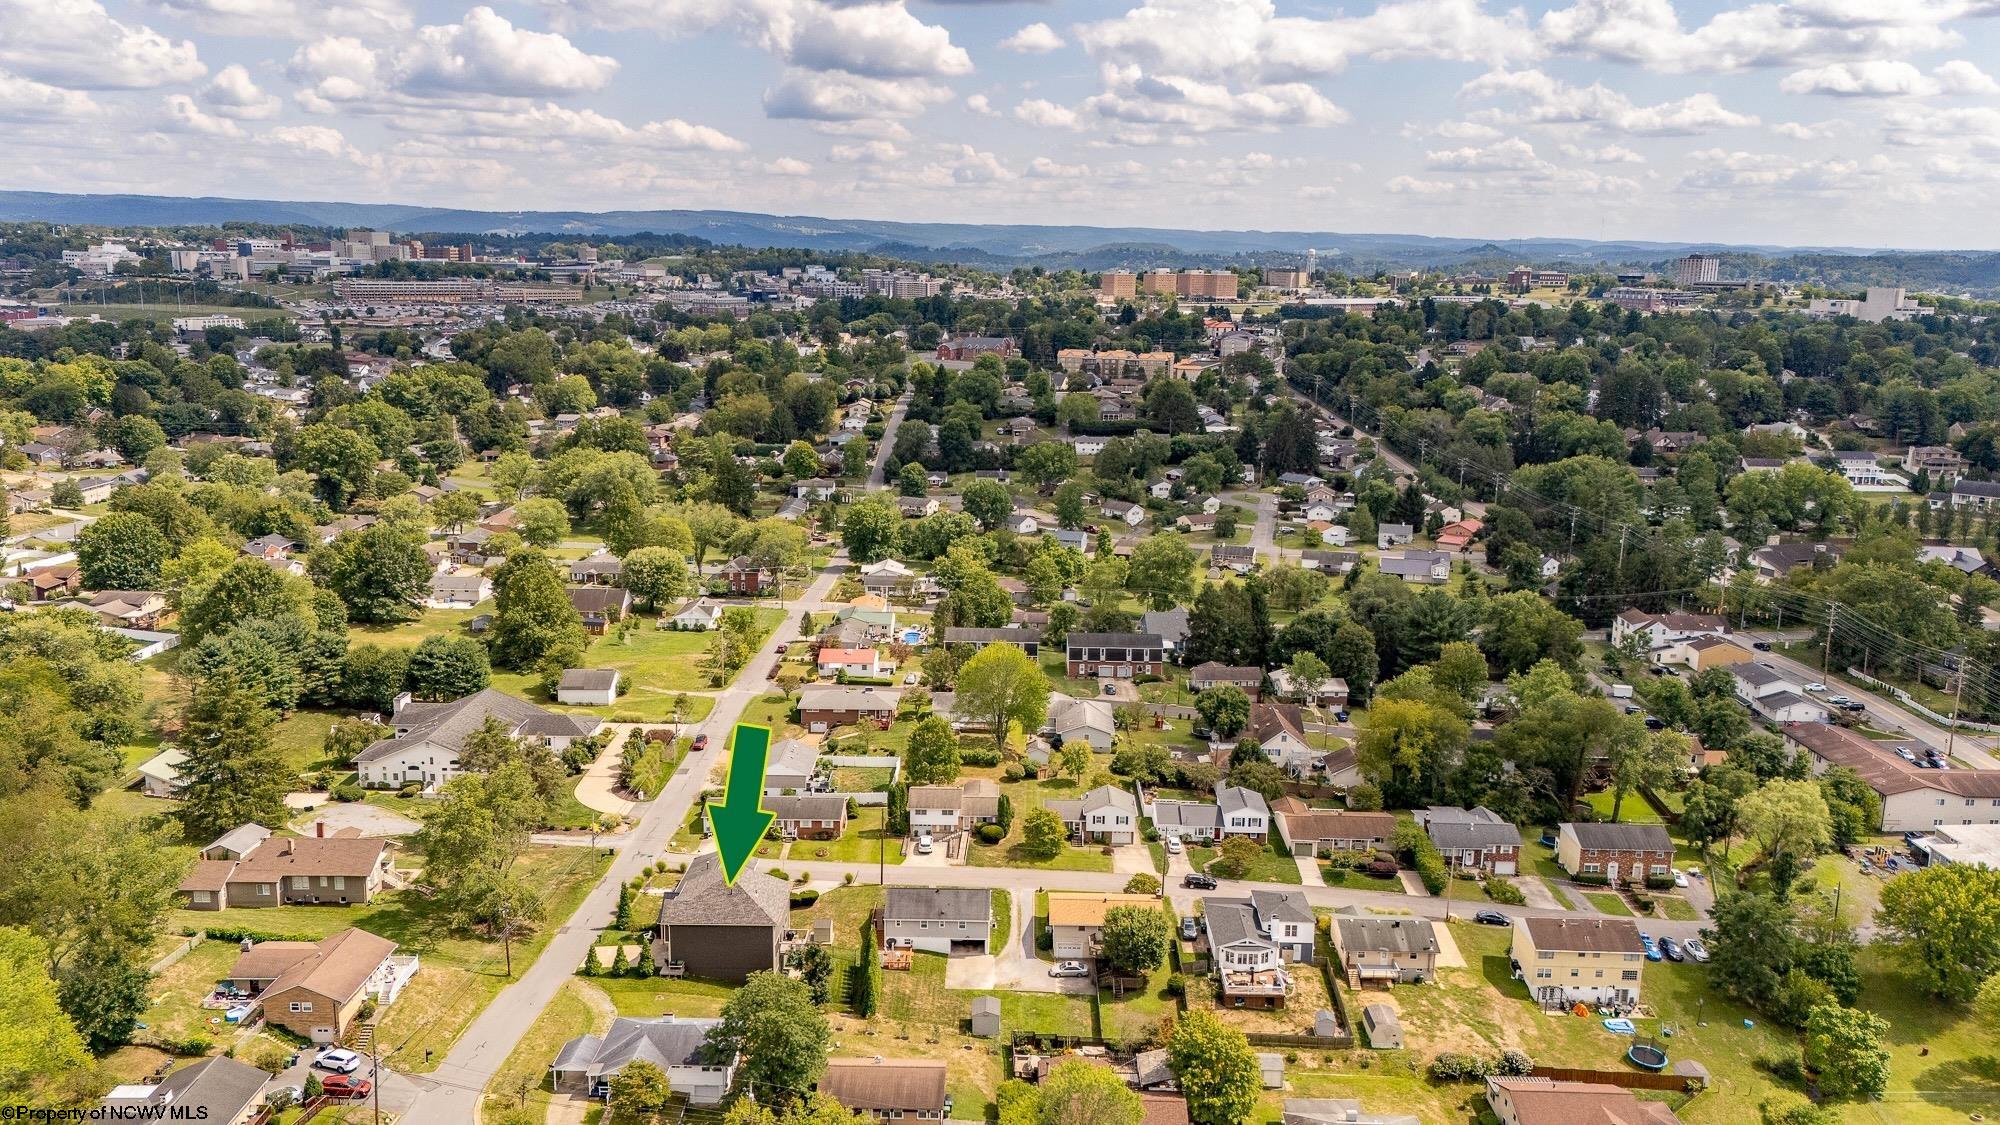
left=652, top=853, right=792, bottom=983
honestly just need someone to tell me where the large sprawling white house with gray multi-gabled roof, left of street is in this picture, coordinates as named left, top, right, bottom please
left=354, top=689, right=604, bottom=789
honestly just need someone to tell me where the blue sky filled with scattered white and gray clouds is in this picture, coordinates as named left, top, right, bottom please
left=0, top=0, right=2000, bottom=248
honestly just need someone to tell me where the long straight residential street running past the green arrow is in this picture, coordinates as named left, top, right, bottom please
left=402, top=552, right=846, bottom=1123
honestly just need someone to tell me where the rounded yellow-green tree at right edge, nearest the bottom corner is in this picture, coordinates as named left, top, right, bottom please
left=1876, top=863, right=2000, bottom=1001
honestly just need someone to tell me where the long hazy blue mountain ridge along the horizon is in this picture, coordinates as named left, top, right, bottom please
left=0, top=192, right=1920, bottom=260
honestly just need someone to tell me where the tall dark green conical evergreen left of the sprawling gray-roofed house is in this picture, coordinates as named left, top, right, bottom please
left=176, top=681, right=298, bottom=841
